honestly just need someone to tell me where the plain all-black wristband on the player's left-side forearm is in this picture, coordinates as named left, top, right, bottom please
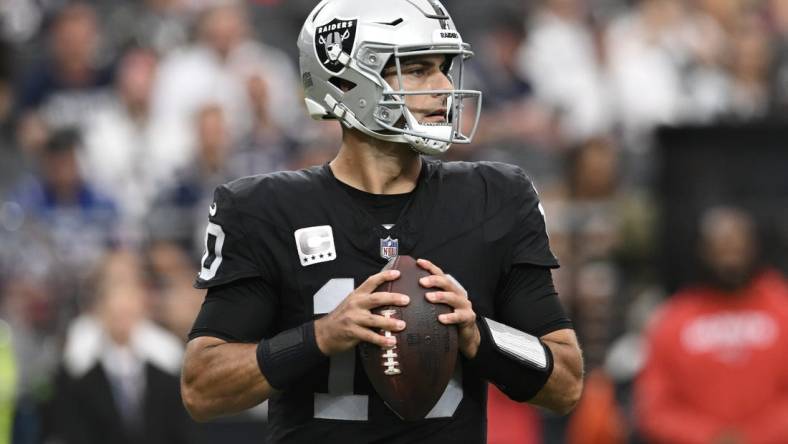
left=257, top=322, right=326, bottom=390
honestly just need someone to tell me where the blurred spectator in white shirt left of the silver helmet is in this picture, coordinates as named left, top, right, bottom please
left=153, top=1, right=300, bottom=182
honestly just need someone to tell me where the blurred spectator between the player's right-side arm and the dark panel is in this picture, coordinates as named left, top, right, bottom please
left=545, top=138, right=624, bottom=368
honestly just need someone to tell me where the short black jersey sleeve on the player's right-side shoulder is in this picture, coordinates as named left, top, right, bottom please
left=512, top=168, right=559, bottom=268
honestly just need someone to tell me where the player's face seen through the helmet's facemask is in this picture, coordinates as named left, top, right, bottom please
left=383, top=54, right=454, bottom=123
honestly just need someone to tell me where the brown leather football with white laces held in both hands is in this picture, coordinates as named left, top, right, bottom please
left=358, top=256, right=457, bottom=420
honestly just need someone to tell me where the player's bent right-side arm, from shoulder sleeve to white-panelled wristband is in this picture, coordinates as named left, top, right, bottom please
left=479, top=169, right=583, bottom=413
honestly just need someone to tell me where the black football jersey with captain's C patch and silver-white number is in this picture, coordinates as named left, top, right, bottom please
left=196, top=160, right=558, bottom=444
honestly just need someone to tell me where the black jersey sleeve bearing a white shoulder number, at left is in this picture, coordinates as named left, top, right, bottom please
left=194, top=185, right=276, bottom=289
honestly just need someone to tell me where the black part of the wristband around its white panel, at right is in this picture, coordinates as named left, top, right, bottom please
left=469, top=316, right=553, bottom=402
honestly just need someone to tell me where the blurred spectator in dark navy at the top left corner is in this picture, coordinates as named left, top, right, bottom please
left=17, top=3, right=112, bottom=128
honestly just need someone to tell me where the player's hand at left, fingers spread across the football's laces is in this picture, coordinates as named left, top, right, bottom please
left=315, top=270, right=410, bottom=356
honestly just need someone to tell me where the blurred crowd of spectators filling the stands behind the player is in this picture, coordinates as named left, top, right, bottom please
left=0, top=0, right=788, bottom=444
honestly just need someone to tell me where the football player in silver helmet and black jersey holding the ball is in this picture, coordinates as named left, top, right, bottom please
left=182, top=0, right=582, bottom=444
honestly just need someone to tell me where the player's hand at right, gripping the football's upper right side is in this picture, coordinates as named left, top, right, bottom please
left=417, top=259, right=481, bottom=359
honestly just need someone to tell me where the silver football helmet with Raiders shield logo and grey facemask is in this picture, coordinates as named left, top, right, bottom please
left=298, top=0, right=481, bottom=155
